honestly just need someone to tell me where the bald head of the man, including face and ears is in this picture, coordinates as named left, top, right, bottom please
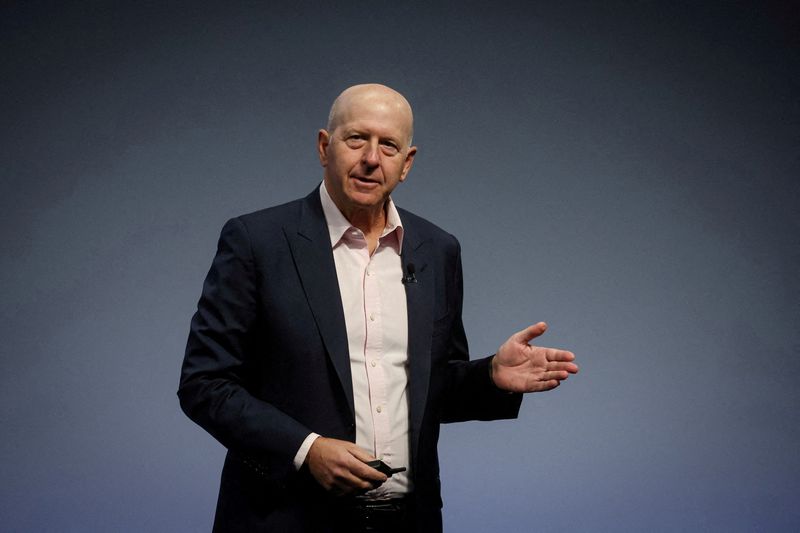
left=317, top=84, right=417, bottom=218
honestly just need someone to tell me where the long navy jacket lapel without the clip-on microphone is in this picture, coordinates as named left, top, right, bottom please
left=284, top=189, right=355, bottom=416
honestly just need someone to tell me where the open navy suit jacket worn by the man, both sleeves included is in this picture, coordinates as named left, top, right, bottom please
left=178, top=190, right=521, bottom=532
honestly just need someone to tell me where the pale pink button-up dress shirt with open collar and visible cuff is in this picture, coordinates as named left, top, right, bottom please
left=295, top=183, right=412, bottom=499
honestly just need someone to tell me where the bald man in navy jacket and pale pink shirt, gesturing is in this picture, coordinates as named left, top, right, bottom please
left=178, top=84, right=578, bottom=532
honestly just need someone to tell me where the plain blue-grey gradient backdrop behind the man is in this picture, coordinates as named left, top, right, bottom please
left=0, top=1, right=800, bottom=532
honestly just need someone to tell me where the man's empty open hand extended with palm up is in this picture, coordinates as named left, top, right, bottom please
left=492, top=322, right=578, bottom=392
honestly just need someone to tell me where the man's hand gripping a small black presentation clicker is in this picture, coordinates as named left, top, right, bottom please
left=306, top=437, right=388, bottom=495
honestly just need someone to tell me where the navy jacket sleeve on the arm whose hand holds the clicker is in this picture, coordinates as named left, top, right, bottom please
left=178, top=219, right=311, bottom=478
